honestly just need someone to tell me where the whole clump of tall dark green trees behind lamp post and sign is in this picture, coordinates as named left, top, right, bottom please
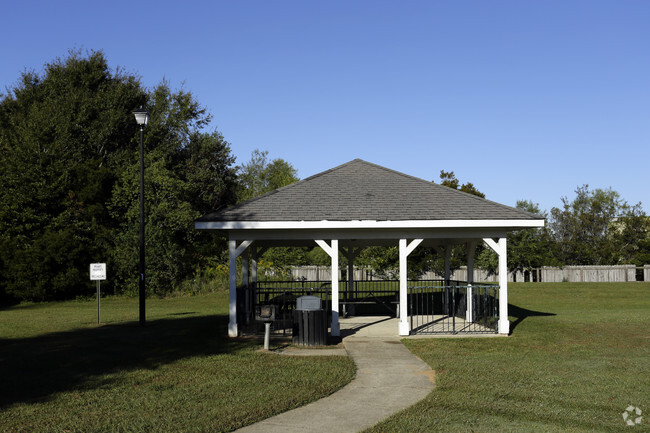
left=0, top=52, right=236, bottom=300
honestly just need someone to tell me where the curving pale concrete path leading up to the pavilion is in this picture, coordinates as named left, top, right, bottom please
left=230, top=325, right=434, bottom=433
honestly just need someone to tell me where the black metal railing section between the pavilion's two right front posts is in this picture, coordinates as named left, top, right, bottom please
left=408, top=284, right=499, bottom=335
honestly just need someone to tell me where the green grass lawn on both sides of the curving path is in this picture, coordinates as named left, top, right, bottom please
left=0, top=283, right=650, bottom=432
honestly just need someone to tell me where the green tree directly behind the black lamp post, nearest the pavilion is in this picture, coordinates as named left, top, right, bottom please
left=110, top=83, right=237, bottom=295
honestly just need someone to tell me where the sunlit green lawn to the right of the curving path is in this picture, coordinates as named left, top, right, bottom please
left=368, top=283, right=650, bottom=432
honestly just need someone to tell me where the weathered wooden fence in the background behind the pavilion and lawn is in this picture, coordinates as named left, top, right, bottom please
left=291, top=265, right=650, bottom=283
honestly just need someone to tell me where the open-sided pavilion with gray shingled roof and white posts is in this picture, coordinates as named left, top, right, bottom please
left=195, top=159, right=544, bottom=337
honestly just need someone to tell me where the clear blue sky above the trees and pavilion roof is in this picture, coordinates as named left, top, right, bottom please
left=0, top=0, right=650, bottom=212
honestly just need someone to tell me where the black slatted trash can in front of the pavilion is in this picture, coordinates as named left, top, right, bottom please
left=293, top=296, right=327, bottom=346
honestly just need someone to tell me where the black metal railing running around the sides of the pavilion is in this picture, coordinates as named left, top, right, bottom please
left=246, top=280, right=498, bottom=335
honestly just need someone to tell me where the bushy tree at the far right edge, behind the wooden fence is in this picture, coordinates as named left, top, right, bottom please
left=549, top=185, right=648, bottom=265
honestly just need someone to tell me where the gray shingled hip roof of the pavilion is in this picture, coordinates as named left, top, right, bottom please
left=197, top=159, right=542, bottom=222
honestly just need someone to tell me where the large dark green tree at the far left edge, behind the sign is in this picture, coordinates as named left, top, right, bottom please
left=0, top=49, right=146, bottom=300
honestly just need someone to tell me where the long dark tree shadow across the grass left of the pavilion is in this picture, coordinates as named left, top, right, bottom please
left=0, top=316, right=251, bottom=410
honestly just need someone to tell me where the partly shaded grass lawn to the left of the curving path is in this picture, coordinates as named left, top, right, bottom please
left=0, top=293, right=355, bottom=432
